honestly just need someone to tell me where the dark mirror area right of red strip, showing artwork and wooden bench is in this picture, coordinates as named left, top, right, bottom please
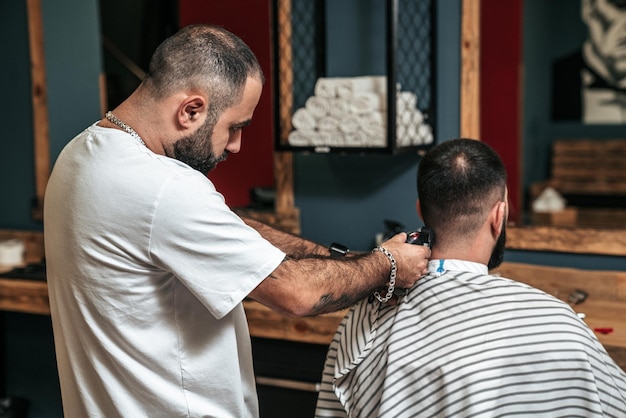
left=521, top=0, right=626, bottom=229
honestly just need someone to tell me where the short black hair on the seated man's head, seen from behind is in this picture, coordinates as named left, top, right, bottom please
left=417, top=138, right=507, bottom=237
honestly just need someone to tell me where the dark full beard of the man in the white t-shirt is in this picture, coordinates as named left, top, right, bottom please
left=165, top=121, right=228, bottom=175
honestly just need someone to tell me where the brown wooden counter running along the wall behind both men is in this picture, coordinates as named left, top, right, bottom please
left=0, top=231, right=626, bottom=368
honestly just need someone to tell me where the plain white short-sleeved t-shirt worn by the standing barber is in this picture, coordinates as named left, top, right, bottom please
left=44, top=125, right=285, bottom=418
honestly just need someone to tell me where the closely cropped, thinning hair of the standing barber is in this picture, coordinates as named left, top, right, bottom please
left=142, top=24, right=264, bottom=121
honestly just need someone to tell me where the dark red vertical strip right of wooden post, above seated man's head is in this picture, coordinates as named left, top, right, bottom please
left=480, top=0, right=523, bottom=222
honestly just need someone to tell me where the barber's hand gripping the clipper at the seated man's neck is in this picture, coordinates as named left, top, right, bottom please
left=381, top=232, right=430, bottom=289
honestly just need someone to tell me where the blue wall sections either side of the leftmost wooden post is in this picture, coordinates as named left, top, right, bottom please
left=0, top=0, right=102, bottom=230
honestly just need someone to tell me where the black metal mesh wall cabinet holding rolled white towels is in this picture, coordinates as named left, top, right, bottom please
left=270, top=0, right=436, bottom=154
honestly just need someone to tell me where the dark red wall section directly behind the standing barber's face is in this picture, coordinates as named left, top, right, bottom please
left=179, top=0, right=274, bottom=207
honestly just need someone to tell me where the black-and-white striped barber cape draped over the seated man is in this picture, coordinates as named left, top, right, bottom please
left=316, top=260, right=626, bottom=418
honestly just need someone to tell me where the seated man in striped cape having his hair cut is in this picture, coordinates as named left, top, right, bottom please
left=316, top=139, right=626, bottom=418
